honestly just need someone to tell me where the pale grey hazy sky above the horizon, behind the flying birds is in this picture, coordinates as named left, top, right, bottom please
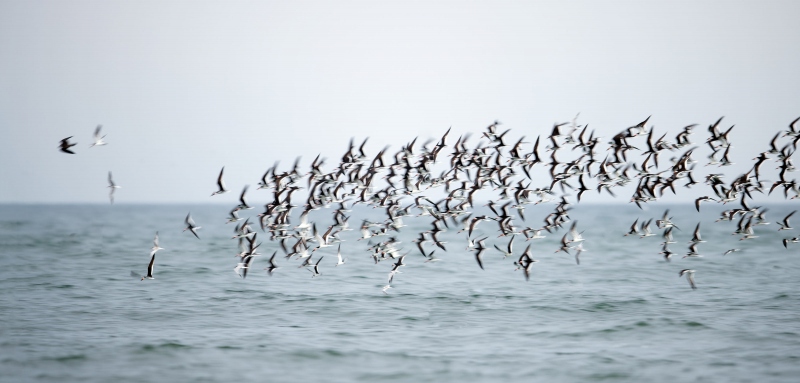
left=0, top=0, right=800, bottom=203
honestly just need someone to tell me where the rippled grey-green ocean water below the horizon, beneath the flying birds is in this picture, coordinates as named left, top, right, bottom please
left=0, top=203, right=800, bottom=382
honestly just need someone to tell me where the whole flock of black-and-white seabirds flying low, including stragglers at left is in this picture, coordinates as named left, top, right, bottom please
left=60, top=116, right=800, bottom=293
